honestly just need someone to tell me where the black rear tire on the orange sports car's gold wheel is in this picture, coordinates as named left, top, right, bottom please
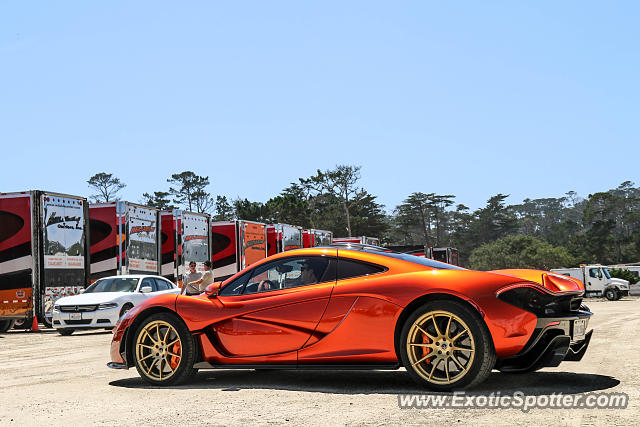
left=399, top=300, right=496, bottom=391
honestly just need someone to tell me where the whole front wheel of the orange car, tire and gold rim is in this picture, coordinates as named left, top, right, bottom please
left=133, top=313, right=195, bottom=386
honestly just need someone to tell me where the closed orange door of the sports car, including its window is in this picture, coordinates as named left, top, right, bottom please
left=214, top=256, right=336, bottom=357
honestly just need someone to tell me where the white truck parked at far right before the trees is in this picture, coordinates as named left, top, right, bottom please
left=551, top=264, right=629, bottom=301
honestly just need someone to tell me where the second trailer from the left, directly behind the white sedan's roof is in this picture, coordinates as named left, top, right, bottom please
left=89, top=201, right=160, bottom=282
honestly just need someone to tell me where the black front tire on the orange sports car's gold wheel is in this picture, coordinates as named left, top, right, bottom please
left=132, top=313, right=197, bottom=386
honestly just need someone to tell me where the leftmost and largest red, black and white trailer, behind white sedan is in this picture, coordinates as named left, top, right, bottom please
left=0, top=190, right=89, bottom=330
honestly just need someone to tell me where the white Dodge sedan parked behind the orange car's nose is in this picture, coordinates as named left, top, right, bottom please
left=53, top=274, right=180, bottom=335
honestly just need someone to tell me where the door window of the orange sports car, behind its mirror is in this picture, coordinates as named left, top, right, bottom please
left=244, top=257, right=335, bottom=294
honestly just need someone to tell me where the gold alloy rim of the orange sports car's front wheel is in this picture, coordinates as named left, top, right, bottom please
left=136, top=320, right=182, bottom=381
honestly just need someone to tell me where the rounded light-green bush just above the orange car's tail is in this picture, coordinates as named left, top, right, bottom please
left=469, top=235, right=574, bottom=270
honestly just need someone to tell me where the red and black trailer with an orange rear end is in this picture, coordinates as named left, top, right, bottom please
left=211, top=220, right=267, bottom=281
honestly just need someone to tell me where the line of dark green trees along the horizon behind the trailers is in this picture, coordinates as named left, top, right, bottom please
left=88, top=169, right=640, bottom=269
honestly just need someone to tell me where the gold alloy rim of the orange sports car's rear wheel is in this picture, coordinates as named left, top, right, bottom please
left=407, top=311, right=475, bottom=384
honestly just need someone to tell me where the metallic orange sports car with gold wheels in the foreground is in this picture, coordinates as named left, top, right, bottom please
left=108, top=245, right=593, bottom=390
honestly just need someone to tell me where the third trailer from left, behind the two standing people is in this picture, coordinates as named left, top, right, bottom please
left=160, top=210, right=211, bottom=285
